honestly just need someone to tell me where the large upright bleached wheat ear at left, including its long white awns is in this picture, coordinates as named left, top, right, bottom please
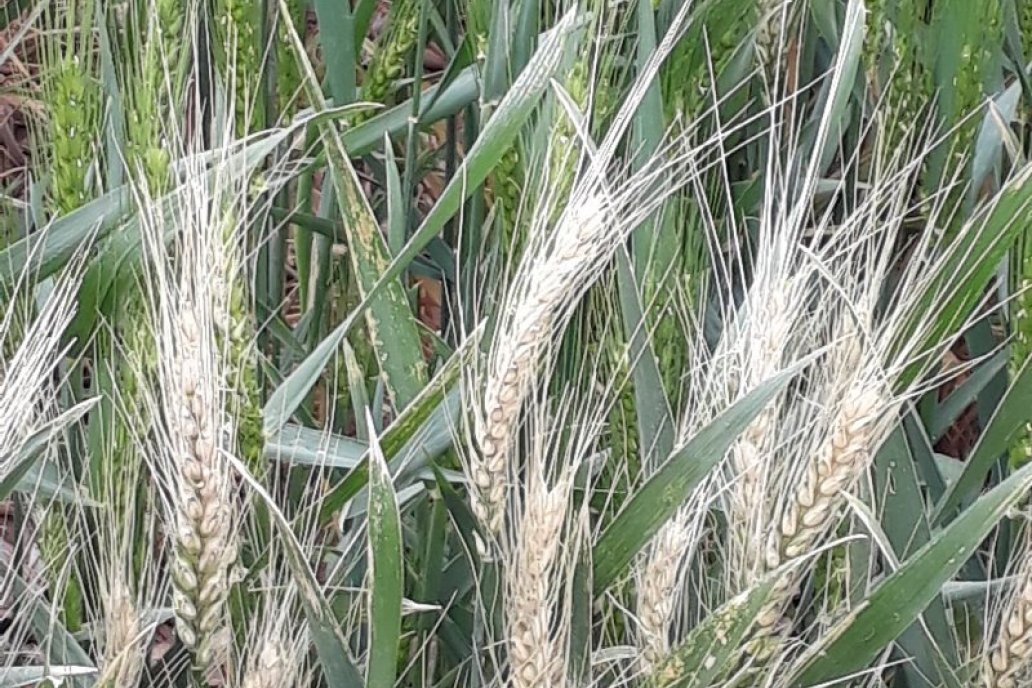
left=139, top=154, right=238, bottom=676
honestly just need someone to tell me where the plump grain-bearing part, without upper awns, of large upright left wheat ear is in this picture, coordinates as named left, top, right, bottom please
left=168, top=303, right=236, bottom=668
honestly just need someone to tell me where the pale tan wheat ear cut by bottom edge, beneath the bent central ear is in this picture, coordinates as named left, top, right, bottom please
left=507, top=477, right=571, bottom=688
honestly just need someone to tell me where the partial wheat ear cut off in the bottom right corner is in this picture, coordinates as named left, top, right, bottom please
left=983, top=524, right=1032, bottom=688
